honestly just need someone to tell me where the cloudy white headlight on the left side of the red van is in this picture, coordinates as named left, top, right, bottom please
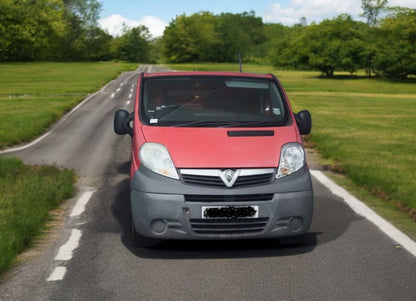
left=139, top=143, right=179, bottom=180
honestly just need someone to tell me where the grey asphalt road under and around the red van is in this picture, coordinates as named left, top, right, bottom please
left=0, top=66, right=416, bottom=300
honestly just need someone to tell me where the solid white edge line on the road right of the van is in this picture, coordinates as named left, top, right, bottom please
left=311, top=170, right=416, bottom=256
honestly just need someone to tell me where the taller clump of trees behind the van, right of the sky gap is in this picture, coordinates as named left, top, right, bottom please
left=161, top=0, right=416, bottom=78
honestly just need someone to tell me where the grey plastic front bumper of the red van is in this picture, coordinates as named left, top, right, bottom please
left=130, top=167, right=313, bottom=239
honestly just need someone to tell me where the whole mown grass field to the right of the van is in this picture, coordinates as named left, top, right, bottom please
left=167, top=64, right=416, bottom=239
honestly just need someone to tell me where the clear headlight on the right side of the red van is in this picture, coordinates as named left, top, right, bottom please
left=276, top=143, right=305, bottom=179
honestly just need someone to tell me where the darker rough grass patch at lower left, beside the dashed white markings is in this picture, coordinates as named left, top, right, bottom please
left=0, top=158, right=75, bottom=274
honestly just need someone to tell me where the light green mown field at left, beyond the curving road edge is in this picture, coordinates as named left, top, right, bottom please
left=0, top=63, right=137, bottom=149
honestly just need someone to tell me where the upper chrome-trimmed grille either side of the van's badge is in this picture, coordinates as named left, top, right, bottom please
left=182, top=170, right=274, bottom=188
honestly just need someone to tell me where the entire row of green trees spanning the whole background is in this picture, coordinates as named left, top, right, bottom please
left=0, top=0, right=416, bottom=78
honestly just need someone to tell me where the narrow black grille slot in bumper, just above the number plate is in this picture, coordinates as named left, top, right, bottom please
left=185, top=193, right=273, bottom=203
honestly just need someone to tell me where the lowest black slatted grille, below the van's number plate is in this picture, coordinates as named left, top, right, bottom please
left=190, top=217, right=269, bottom=235
